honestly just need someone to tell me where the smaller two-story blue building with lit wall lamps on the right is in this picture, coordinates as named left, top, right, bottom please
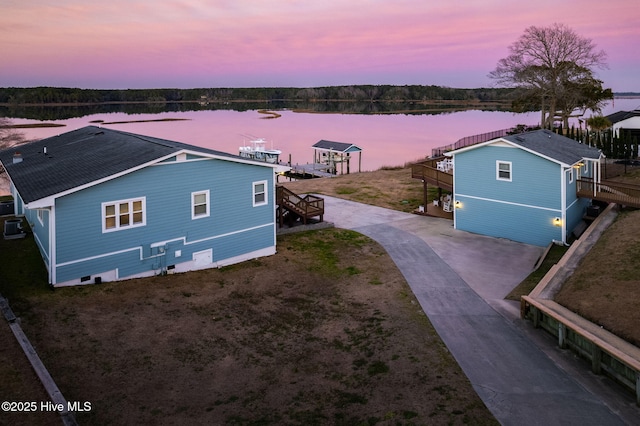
left=446, top=130, right=603, bottom=246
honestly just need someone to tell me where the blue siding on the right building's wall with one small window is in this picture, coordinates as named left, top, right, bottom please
left=454, top=145, right=563, bottom=246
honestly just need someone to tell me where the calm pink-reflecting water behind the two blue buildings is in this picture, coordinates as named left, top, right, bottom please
left=6, top=99, right=640, bottom=171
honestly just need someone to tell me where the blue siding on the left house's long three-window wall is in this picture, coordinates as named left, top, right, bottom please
left=56, top=156, right=275, bottom=282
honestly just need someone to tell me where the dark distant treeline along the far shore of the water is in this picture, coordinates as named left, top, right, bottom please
left=0, top=85, right=515, bottom=105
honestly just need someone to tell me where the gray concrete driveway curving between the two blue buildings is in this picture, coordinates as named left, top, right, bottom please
left=323, top=196, right=640, bottom=425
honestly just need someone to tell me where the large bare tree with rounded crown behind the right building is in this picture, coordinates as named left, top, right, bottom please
left=489, top=24, right=612, bottom=127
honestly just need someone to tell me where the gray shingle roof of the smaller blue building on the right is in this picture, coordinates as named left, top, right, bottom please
left=502, top=130, right=601, bottom=165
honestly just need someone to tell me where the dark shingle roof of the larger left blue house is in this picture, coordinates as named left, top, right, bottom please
left=0, top=126, right=248, bottom=203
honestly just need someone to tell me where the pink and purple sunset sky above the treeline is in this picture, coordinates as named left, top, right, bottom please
left=0, top=0, right=640, bottom=92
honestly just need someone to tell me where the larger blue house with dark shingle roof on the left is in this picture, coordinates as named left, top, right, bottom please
left=0, top=126, right=279, bottom=286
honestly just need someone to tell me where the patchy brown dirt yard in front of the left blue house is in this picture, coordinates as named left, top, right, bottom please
left=0, top=225, right=496, bottom=425
